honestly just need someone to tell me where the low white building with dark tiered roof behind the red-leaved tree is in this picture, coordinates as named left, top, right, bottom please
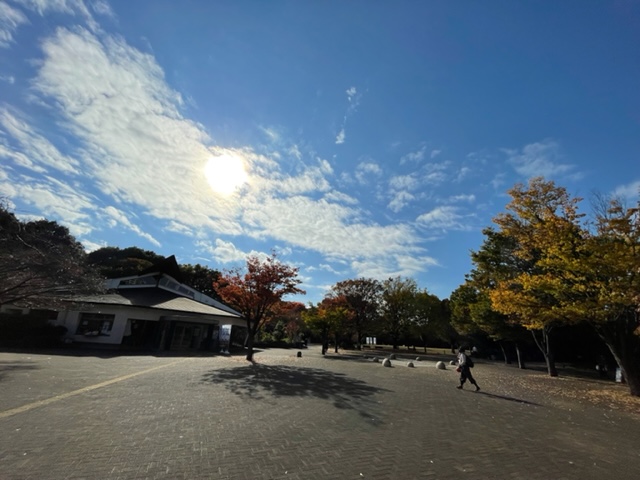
left=53, top=256, right=246, bottom=351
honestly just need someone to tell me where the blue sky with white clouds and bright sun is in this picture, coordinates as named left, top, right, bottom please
left=0, top=0, right=640, bottom=303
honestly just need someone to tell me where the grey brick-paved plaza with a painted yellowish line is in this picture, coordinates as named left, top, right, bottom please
left=0, top=348, right=640, bottom=480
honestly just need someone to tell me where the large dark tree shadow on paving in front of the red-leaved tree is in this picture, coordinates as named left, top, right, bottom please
left=202, top=363, right=390, bottom=417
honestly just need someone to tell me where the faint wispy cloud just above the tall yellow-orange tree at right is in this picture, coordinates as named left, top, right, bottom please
left=503, top=139, right=574, bottom=177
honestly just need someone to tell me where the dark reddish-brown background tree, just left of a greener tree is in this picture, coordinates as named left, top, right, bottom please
left=332, top=278, right=382, bottom=349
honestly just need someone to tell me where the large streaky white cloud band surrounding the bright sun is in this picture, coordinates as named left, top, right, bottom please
left=0, top=20, right=438, bottom=286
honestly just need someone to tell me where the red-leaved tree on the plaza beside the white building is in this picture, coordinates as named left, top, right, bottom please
left=214, top=253, right=305, bottom=362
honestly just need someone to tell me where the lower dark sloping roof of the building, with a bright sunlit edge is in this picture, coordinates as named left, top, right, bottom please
left=70, top=288, right=241, bottom=319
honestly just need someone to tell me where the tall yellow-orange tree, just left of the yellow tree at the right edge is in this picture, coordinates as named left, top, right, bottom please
left=489, top=177, right=582, bottom=376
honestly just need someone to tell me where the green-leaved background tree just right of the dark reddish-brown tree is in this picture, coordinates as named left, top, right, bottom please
left=380, top=277, right=418, bottom=349
